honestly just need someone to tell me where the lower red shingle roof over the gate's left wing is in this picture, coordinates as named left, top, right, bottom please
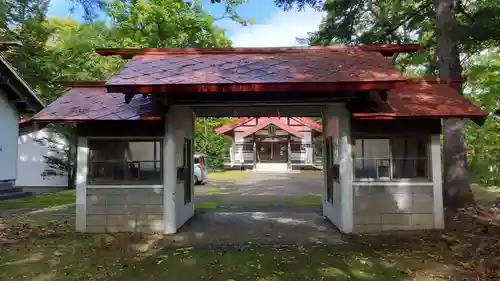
left=23, top=82, right=161, bottom=122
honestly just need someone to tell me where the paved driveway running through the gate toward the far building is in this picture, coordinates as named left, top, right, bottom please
left=164, top=172, right=342, bottom=246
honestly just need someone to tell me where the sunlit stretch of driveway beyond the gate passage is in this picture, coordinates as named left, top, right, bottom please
left=195, top=171, right=323, bottom=213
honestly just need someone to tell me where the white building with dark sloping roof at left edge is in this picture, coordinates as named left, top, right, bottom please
left=0, top=56, right=67, bottom=200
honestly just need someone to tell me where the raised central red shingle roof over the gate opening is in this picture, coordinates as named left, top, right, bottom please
left=106, top=47, right=406, bottom=93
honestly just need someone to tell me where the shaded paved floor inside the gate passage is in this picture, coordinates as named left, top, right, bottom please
left=167, top=211, right=343, bottom=246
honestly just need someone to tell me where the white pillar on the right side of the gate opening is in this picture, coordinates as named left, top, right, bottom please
left=338, top=107, right=354, bottom=233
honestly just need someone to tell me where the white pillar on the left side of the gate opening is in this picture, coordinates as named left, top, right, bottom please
left=162, top=108, right=177, bottom=234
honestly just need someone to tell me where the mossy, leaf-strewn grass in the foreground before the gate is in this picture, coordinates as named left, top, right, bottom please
left=0, top=229, right=446, bottom=281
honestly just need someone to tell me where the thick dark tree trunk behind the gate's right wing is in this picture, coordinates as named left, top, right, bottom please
left=434, top=0, right=474, bottom=214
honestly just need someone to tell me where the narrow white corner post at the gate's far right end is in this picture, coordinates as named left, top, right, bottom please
left=431, top=135, right=444, bottom=229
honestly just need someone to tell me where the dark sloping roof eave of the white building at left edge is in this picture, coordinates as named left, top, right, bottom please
left=0, top=54, right=45, bottom=113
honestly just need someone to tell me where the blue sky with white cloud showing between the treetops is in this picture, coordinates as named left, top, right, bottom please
left=48, top=0, right=324, bottom=47
